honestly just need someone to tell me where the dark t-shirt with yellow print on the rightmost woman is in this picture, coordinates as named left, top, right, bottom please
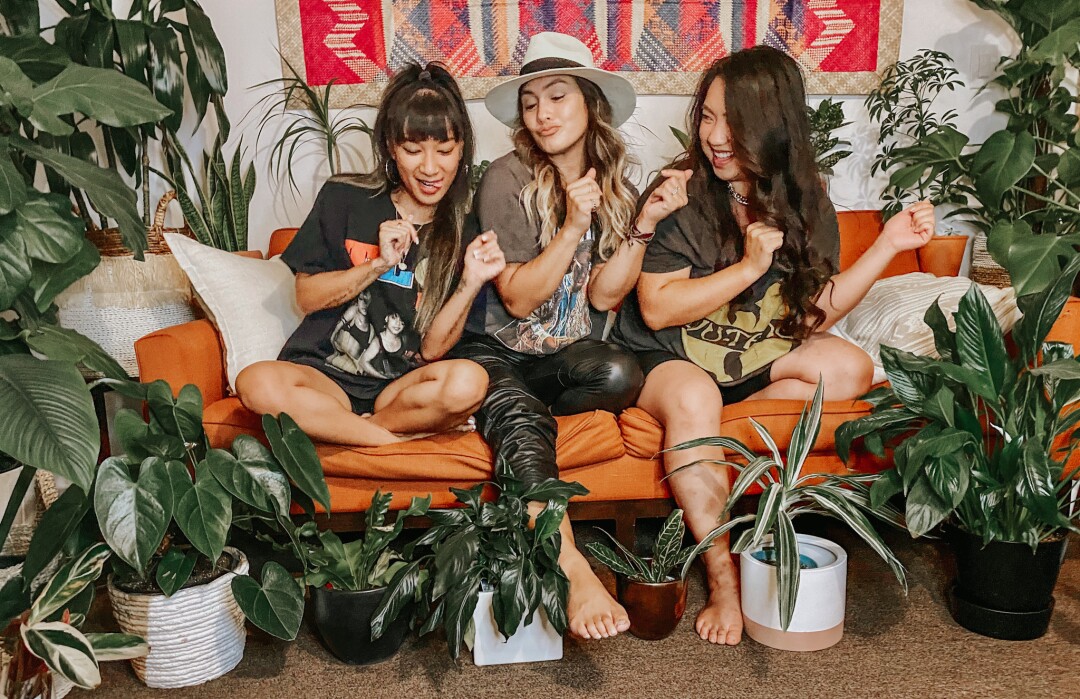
left=611, top=199, right=840, bottom=387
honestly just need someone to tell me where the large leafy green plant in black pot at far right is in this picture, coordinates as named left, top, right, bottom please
left=836, top=257, right=1080, bottom=640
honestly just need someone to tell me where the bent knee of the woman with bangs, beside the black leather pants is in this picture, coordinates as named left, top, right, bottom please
left=370, top=360, right=487, bottom=433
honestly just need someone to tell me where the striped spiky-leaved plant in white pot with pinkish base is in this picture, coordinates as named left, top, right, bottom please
left=671, top=384, right=907, bottom=650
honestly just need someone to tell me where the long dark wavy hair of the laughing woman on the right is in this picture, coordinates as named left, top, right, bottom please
left=665, top=46, right=836, bottom=339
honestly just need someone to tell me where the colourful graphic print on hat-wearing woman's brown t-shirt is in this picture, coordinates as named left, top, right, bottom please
left=495, top=231, right=593, bottom=354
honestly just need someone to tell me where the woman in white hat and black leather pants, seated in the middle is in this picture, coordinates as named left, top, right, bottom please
left=455, top=32, right=689, bottom=638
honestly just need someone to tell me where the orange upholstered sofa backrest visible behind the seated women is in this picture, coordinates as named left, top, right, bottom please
left=267, top=211, right=967, bottom=277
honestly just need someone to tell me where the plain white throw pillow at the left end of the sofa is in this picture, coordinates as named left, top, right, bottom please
left=165, top=233, right=303, bottom=390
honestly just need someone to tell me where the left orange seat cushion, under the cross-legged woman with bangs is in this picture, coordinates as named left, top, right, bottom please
left=203, top=398, right=625, bottom=487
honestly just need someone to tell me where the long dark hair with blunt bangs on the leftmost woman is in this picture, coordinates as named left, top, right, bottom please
left=335, top=63, right=476, bottom=335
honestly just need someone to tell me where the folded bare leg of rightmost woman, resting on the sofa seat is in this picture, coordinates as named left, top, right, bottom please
left=751, top=333, right=874, bottom=401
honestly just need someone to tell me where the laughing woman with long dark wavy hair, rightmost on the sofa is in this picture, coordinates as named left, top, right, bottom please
left=612, top=46, right=934, bottom=645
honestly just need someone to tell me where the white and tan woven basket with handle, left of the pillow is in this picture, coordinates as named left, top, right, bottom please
left=56, top=191, right=195, bottom=377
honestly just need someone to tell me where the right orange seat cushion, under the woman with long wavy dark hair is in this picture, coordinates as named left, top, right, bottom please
left=619, top=401, right=869, bottom=464
